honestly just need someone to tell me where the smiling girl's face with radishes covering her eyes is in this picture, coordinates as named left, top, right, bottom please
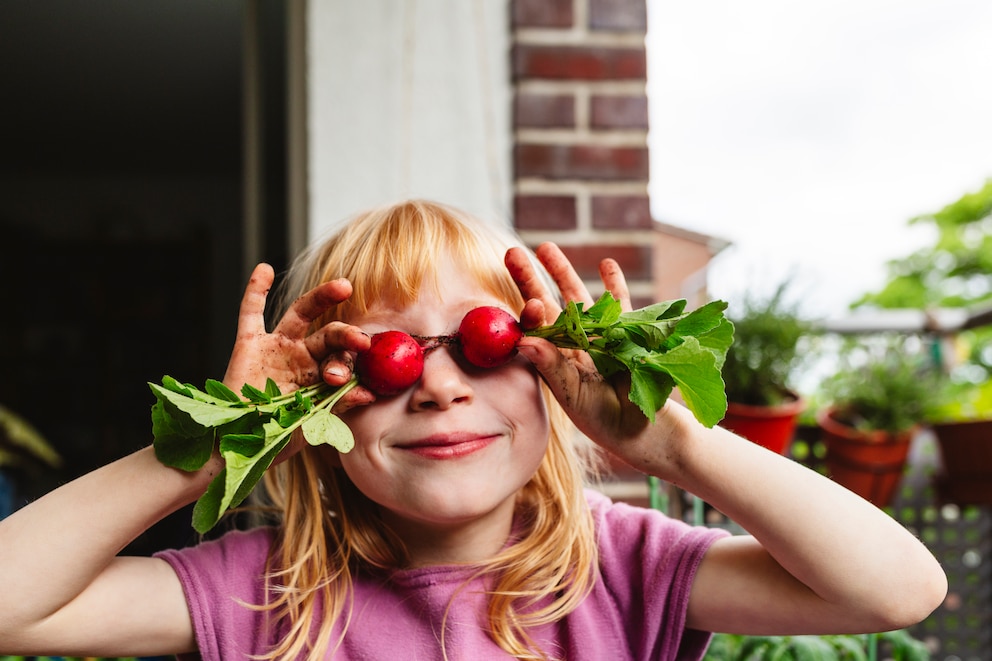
left=340, top=266, right=549, bottom=548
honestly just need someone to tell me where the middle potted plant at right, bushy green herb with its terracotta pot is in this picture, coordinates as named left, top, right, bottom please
left=816, top=343, right=936, bottom=507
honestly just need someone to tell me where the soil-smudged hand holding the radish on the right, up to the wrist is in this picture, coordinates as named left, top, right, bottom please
left=505, top=243, right=664, bottom=452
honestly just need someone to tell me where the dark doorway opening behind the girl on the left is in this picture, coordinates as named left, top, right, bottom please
left=0, top=0, right=285, bottom=553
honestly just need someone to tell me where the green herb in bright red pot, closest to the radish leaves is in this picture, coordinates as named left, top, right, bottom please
left=720, top=283, right=812, bottom=454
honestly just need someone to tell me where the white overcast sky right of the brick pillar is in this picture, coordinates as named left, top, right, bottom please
left=648, top=0, right=992, bottom=316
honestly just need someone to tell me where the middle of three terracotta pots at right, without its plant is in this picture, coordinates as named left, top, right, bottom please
left=816, top=409, right=918, bottom=507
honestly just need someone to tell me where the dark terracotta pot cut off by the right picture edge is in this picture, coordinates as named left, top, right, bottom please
left=933, top=420, right=992, bottom=505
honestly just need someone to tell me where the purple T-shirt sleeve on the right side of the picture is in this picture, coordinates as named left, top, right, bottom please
left=589, top=494, right=729, bottom=660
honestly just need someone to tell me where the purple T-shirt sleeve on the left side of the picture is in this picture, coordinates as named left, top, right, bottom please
left=155, top=528, right=273, bottom=661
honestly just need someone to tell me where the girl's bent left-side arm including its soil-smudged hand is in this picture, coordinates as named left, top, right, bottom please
left=0, top=265, right=369, bottom=656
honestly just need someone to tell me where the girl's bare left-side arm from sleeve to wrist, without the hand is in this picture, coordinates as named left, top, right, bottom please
left=0, top=448, right=214, bottom=656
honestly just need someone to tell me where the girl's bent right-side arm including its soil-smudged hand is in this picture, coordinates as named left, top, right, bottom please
left=507, top=244, right=947, bottom=634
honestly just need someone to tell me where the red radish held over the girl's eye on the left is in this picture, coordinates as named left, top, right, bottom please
left=356, top=331, right=424, bottom=395
